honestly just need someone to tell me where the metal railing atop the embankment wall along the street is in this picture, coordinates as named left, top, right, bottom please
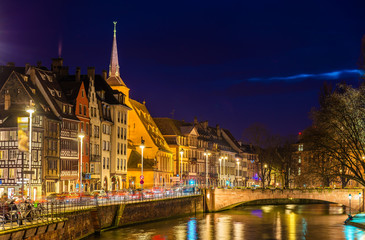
left=0, top=188, right=201, bottom=232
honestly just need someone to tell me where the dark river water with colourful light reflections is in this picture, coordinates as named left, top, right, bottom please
left=88, top=204, right=365, bottom=240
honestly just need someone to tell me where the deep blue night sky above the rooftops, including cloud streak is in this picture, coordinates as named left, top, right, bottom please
left=0, top=0, right=365, bottom=139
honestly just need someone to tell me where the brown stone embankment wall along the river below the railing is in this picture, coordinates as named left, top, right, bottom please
left=0, top=196, right=204, bottom=240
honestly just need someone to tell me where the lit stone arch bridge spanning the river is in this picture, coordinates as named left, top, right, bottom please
left=205, top=189, right=364, bottom=212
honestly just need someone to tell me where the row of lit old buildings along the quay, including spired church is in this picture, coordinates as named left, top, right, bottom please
left=0, top=24, right=257, bottom=197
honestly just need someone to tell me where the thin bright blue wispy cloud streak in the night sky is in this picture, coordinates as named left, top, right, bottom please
left=248, top=69, right=364, bottom=82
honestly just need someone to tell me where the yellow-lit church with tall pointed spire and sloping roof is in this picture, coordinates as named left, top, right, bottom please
left=107, top=22, right=173, bottom=188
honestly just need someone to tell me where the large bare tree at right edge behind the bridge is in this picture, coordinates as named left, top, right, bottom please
left=306, top=84, right=365, bottom=185
